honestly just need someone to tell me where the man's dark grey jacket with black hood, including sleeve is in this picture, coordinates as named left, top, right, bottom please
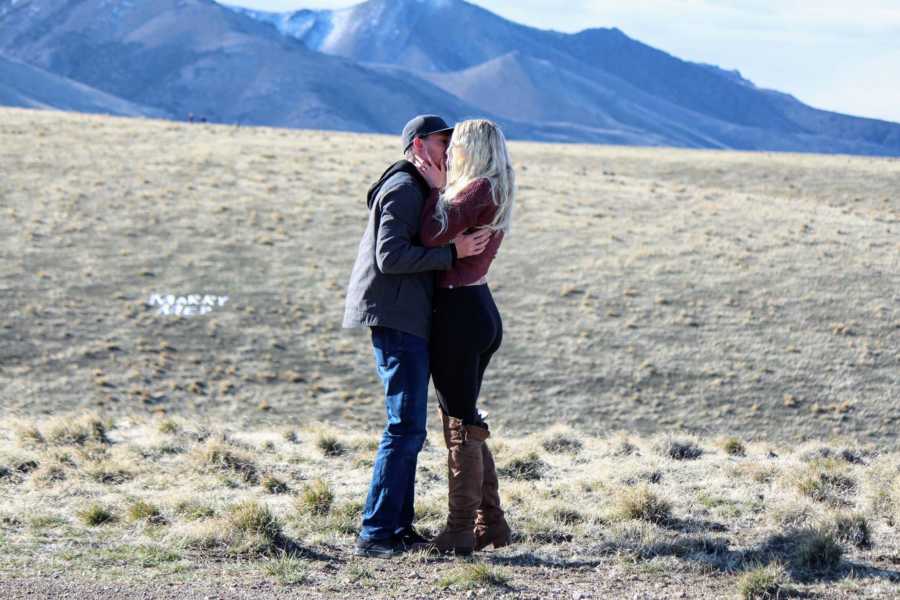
left=344, top=160, right=456, bottom=339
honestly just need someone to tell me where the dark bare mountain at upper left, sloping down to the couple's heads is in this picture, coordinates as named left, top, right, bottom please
left=0, top=0, right=492, bottom=132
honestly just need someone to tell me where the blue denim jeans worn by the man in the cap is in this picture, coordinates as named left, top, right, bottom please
left=359, top=327, right=429, bottom=541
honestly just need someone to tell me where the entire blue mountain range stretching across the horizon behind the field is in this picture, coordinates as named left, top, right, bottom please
left=0, top=0, right=900, bottom=156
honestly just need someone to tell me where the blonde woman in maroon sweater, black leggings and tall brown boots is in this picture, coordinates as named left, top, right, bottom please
left=417, top=120, right=515, bottom=554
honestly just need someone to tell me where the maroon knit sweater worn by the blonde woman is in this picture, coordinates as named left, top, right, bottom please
left=420, top=178, right=503, bottom=288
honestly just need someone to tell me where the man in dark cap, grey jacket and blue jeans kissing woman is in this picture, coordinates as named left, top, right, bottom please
left=344, top=115, right=490, bottom=558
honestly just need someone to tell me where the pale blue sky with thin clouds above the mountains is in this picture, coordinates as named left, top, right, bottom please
left=225, top=0, right=900, bottom=122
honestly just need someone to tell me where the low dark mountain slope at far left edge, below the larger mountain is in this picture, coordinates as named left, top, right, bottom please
left=0, top=56, right=168, bottom=118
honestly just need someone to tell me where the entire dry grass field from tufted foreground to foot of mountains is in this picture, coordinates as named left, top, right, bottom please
left=0, top=109, right=900, bottom=598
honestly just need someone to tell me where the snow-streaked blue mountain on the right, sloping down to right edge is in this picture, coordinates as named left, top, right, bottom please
left=234, top=0, right=900, bottom=155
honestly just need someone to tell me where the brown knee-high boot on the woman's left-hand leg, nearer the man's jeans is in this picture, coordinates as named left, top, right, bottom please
left=431, top=416, right=490, bottom=555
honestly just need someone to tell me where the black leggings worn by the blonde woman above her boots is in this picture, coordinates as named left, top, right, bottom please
left=430, top=284, right=503, bottom=425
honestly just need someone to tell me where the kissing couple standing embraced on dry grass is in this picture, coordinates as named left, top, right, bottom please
left=343, top=115, right=515, bottom=558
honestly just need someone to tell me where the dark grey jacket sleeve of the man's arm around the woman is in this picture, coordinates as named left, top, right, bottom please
left=375, top=186, right=456, bottom=275
